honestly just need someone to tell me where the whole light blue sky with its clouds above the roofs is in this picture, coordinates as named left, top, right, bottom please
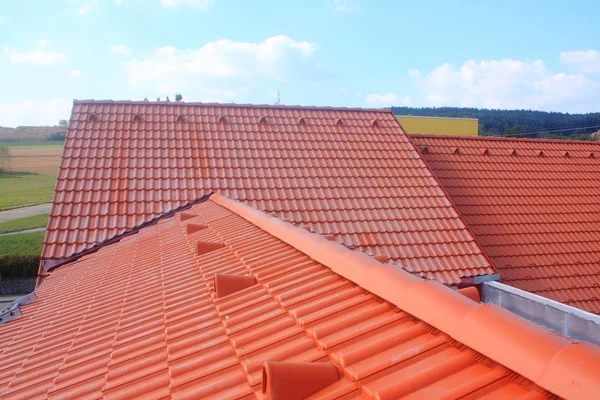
left=0, top=0, right=600, bottom=126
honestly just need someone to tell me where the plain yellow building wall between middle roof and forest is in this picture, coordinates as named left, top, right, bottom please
left=396, top=115, right=479, bottom=136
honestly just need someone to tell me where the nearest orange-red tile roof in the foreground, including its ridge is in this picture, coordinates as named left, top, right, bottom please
left=0, top=196, right=600, bottom=399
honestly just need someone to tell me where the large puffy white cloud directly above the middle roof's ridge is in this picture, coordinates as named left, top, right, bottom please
left=125, top=36, right=323, bottom=101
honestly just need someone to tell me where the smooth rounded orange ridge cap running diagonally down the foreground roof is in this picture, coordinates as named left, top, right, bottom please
left=211, top=194, right=600, bottom=398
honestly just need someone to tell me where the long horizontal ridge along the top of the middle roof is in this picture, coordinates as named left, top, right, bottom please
left=73, top=99, right=393, bottom=115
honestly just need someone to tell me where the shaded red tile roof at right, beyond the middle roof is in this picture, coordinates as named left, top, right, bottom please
left=412, top=136, right=600, bottom=314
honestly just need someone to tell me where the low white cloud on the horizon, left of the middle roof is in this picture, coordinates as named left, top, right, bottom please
left=0, top=99, right=73, bottom=127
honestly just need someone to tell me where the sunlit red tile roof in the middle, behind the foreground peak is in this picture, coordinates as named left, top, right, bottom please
left=43, top=101, right=495, bottom=283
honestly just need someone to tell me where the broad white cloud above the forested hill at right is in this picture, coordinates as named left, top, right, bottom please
left=408, top=59, right=600, bottom=112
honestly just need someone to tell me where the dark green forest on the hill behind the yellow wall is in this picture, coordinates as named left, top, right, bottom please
left=392, top=107, right=600, bottom=140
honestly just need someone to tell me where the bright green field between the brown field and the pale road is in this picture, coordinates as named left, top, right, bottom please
left=0, top=172, right=56, bottom=210
